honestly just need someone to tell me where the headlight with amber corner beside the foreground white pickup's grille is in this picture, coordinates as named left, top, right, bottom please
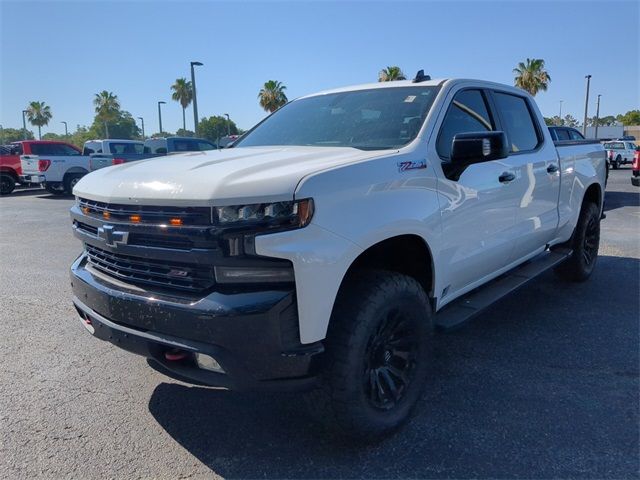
left=215, top=198, right=313, bottom=229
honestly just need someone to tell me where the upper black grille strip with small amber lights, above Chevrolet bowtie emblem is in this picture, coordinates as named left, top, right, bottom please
left=78, top=198, right=211, bottom=225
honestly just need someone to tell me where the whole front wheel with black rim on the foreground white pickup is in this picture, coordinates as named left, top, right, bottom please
left=308, top=270, right=433, bottom=442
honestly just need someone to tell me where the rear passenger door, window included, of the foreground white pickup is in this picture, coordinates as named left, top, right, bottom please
left=491, top=90, right=560, bottom=261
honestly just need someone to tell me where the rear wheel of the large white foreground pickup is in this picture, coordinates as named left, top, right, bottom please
left=556, top=202, right=600, bottom=282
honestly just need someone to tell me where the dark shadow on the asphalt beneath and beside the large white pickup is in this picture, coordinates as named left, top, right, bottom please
left=149, top=256, right=640, bottom=478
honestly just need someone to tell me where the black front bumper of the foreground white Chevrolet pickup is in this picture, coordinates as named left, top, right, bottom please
left=71, top=254, right=323, bottom=390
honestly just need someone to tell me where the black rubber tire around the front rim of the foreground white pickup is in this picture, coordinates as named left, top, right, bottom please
left=324, top=272, right=433, bottom=441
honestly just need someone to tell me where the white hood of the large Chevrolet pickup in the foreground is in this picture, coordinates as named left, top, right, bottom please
left=73, top=146, right=390, bottom=206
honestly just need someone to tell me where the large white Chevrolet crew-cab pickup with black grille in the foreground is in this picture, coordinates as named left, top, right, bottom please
left=71, top=77, right=605, bottom=440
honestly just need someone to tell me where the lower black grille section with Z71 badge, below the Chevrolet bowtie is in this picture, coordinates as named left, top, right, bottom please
left=85, top=244, right=214, bottom=292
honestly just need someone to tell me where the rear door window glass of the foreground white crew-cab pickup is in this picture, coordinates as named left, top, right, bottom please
left=495, top=92, right=539, bottom=152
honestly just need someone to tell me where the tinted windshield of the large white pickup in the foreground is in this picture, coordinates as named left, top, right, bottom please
left=234, top=86, right=438, bottom=150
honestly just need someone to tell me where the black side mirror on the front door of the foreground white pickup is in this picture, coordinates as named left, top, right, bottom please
left=451, top=132, right=509, bottom=165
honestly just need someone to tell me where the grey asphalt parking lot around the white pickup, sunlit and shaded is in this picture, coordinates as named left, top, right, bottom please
left=0, top=168, right=640, bottom=478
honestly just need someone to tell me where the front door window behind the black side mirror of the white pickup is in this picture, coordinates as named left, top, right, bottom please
left=436, top=90, right=495, bottom=159
